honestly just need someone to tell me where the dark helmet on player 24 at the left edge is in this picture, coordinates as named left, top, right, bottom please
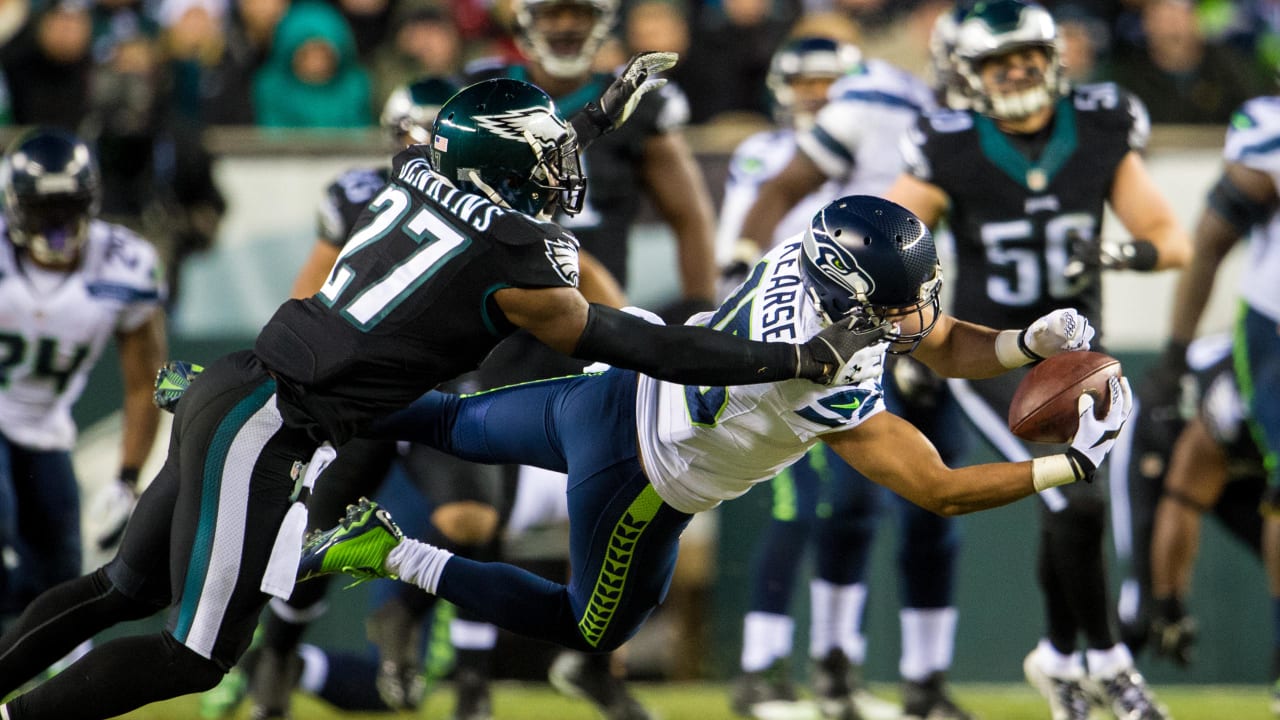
left=0, top=128, right=101, bottom=264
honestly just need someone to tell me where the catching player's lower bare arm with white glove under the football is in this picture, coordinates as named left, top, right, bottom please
left=823, top=378, right=1133, bottom=515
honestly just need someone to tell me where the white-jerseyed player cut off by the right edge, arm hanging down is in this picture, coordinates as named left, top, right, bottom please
left=1156, top=90, right=1280, bottom=715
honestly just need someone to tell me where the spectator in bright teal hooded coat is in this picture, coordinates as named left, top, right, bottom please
left=253, top=0, right=372, bottom=128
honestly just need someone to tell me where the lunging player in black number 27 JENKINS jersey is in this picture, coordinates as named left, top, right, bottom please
left=0, top=77, right=883, bottom=720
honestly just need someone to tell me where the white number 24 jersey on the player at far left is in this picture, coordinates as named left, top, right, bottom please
left=0, top=218, right=165, bottom=450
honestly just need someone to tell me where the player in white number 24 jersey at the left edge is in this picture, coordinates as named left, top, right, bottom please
left=0, top=128, right=166, bottom=648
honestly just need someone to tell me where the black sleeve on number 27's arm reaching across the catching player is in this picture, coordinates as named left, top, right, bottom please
left=573, top=304, right=799, bottom=386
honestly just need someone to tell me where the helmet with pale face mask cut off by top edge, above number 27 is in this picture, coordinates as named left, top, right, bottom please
left=513, top=0, right=618, bottom=79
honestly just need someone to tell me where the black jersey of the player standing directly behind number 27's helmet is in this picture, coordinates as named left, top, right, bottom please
left=466, top=63, right=689, bottom=286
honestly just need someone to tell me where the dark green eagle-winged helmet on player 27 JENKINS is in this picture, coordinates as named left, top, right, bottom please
left=431, top=78, right=586, bottom=217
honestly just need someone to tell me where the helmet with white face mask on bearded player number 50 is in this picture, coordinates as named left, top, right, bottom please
left=955, top=0, right=1068, bottom=120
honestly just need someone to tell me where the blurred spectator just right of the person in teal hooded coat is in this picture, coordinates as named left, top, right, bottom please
left=371, top=0, right=462, bottom=108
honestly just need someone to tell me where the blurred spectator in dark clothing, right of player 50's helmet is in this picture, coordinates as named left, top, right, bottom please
left=1114, top=0, right=1263, bottom=123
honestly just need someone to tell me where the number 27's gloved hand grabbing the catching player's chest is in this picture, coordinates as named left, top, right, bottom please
left=796, top=318, right=893, bottom=386
